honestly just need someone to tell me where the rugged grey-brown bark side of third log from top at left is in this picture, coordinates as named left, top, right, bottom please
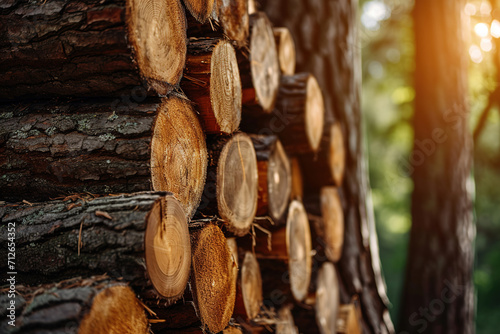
left=0, top=193, right=189, bottom=299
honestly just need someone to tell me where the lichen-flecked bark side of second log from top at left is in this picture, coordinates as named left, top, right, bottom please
left=0, top=100, right=160, bottom=201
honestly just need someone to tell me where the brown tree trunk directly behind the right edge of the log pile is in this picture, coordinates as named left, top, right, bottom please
left=260, top=0, right=393, bottom=333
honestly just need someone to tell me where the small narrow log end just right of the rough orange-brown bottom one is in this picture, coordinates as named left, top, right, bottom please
left=233, top=252, right=263, bottom=322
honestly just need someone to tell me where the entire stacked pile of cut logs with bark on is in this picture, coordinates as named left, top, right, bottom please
left=0, top=0, right=360, bottom=334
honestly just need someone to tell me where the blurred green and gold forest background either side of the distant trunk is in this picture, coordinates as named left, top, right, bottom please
left=359, top=0, right=500, bottom=333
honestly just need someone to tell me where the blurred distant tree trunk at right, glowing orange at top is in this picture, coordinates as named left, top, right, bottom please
left=399, top=0, right=475, bottom=333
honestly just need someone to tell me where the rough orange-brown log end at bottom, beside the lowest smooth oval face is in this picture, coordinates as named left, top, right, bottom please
left=191, top=224, right=237, bottom=333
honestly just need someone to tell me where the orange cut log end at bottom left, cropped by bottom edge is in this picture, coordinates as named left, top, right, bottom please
left=78, top=285, right=149, bottom=334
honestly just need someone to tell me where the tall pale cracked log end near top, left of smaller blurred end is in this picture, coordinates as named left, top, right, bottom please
left=250, top=13, right=280, bottom=112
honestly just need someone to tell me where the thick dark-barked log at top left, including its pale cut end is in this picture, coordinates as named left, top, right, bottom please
left=0, top=0, right=186, bottom=102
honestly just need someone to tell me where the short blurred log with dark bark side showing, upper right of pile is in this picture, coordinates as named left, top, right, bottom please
left=241, top=73, right=324, bottom=155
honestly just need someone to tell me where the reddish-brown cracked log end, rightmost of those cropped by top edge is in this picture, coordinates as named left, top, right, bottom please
left=217, top=0, right=249, bottom=47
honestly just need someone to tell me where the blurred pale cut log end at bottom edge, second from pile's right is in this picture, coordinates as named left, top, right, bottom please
left=314, top=262, right=340, bottom=334
